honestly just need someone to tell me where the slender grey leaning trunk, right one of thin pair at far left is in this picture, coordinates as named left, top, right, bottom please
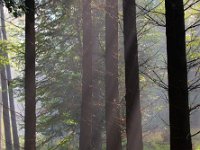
left=1, top=4, right=19, bottom=150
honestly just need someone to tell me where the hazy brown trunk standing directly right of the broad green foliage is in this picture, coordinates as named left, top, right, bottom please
left=79, top=0, right=92, bottom=150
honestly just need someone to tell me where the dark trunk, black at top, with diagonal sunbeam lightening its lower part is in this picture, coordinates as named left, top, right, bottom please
left=123, top=0, right=143, bottom=150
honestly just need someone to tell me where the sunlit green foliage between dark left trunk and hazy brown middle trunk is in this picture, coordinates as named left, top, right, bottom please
left=32, top=0, right=81, bottom=150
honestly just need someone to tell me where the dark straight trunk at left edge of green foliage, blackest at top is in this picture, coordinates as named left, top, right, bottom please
left=25, top=0, right=36, bottom=150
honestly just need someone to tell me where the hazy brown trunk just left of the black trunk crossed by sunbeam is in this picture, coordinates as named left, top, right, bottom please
left=105, top=0, right=122, bottom=150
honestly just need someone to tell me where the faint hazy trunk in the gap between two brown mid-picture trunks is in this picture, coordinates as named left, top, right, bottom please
left=92, top=10, right=103, bottom=150
